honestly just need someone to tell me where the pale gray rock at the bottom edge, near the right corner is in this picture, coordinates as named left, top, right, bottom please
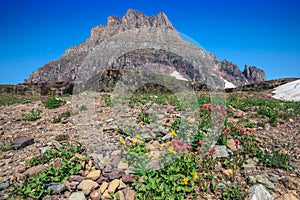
left=247, top=184, right=274, bottom=200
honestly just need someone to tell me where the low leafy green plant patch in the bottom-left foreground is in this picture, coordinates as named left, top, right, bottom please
left=9, top=143, right=86, bottom=199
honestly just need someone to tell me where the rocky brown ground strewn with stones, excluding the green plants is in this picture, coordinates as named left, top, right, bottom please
left=0, top=90, right=300, bottom=200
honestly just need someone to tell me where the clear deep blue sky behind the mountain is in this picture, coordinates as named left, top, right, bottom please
left=0, top=0, right=300, bottom=84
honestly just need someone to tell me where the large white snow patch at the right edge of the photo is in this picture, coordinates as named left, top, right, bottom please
left=273, top=80, right=300, bottom=101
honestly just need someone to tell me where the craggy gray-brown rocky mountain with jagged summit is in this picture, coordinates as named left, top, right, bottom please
left=24, top=9, right=266, bottom=87
